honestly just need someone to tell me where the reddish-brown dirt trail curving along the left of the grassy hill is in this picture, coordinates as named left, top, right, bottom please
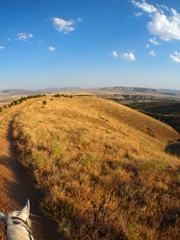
left=0, top=103, right=64, bottom=240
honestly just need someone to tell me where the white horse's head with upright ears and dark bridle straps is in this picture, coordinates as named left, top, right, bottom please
left=0, top=200, right=34, bottom=240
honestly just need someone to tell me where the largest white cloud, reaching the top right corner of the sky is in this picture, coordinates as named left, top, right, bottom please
left=132, top=0, right=180, bottom=41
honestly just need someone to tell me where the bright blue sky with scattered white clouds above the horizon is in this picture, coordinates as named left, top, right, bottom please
left=0, top=0, right=180, bottom=90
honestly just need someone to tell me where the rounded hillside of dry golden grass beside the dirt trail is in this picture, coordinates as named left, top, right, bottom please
left=13, top=97, right=180, bottom=239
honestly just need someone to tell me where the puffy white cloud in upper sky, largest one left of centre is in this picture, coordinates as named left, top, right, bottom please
left=52, top=17, right=75, bottom=34
